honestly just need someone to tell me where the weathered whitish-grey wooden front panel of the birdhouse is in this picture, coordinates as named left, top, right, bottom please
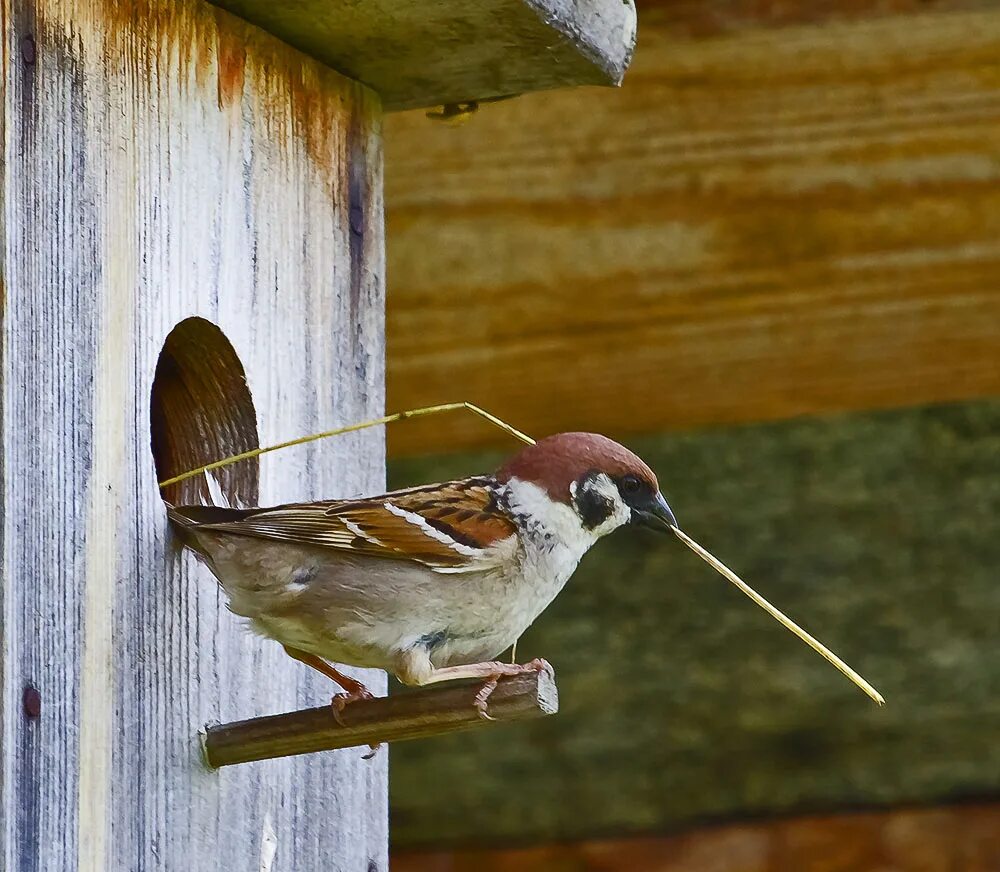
left=0, top=0, right=387, bottom=872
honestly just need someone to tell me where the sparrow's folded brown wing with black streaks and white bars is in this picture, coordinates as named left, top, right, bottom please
left=178, top=478, right=517, bottom=572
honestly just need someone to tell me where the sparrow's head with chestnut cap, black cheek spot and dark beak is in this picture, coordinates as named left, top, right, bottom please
left=497, top=433, right=677, bottom=536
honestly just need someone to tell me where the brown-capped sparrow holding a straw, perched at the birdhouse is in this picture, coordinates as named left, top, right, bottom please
left=167, top=433, right=677, bottom=717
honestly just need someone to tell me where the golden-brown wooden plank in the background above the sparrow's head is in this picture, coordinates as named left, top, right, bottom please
left=386, top=3, right=1000, bottom=454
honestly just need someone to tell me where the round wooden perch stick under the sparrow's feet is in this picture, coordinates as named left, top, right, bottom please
left=199, top=671, right=559, bottom=768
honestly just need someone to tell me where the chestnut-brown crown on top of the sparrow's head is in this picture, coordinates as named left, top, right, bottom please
left=496, top=433, right=659, bottom=502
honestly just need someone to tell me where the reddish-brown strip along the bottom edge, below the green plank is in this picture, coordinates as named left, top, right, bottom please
left=392, top=803, right=1000, bottom=872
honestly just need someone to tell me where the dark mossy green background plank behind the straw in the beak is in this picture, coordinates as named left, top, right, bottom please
left=390, top=401, right=1000, bottom=848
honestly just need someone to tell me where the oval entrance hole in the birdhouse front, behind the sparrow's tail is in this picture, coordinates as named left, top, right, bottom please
left=150, top=318, right=260, bottom=506
